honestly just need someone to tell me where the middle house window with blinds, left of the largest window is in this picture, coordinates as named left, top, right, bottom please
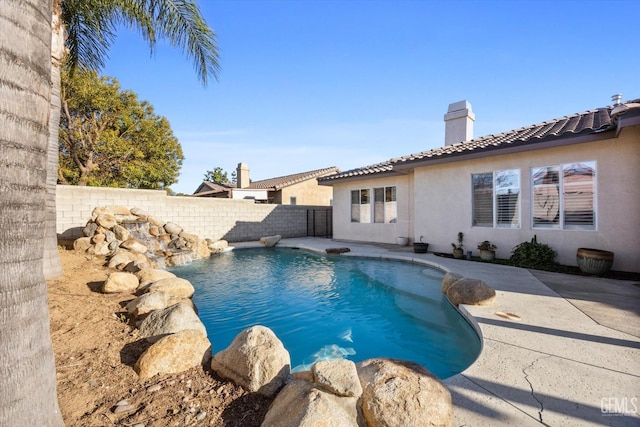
left=471, top=169, right=520, bottom=228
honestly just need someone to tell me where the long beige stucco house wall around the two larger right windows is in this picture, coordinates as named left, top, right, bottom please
left=410, top=126, right=640, bottom=272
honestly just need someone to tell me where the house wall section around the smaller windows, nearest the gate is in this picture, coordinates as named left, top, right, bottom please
left=333, top=175, right=412, bottom=243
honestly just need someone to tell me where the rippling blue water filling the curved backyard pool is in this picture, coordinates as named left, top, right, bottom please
left=172, top=248, right=480, bottom=378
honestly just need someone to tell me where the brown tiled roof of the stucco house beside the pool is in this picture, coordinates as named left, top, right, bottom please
left=318, top=99, right=640, bottom=183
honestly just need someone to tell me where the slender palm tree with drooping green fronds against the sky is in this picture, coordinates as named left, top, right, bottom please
left=44, top=0, right=219, bottom=279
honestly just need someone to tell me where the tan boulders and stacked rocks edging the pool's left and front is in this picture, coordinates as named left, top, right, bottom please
left=74, top=207, right=453, bottom=427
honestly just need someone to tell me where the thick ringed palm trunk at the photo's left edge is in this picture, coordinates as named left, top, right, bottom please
left=0, top=0, right=63, bottom=426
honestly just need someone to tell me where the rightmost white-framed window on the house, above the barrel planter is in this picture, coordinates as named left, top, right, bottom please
left=531, top=161, right=596, bottom=230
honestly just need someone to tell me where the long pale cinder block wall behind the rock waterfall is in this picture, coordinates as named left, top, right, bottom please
left=56, top=185, right=331, bottom=242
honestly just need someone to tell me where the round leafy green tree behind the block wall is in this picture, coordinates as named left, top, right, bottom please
left=58, top=70, right=183, bottom=189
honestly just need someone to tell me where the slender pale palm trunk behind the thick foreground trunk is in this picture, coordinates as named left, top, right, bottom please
left=43, top=0, right=64, bottom=280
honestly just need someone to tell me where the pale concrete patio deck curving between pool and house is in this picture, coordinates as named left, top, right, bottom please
left=233, top=238, right=640, bottom=427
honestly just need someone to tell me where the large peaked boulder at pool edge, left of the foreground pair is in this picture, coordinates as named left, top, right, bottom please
left=211, top=325, right=291, bottom=396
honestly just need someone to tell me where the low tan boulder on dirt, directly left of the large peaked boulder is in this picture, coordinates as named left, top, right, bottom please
left=134, top=329, right=211, bottom=378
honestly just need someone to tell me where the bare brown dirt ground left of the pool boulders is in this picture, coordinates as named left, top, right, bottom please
left=47, top=250, right=271, bottom=427
